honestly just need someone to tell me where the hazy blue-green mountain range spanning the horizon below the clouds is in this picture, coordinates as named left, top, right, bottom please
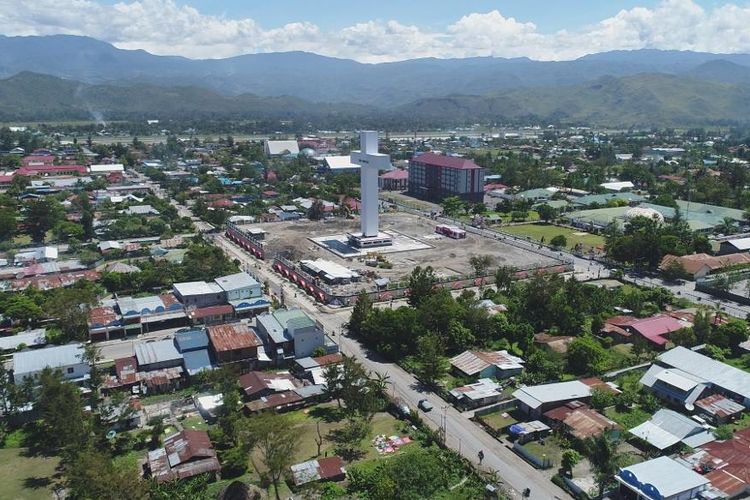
left=0, top=35, right=750, bottom=126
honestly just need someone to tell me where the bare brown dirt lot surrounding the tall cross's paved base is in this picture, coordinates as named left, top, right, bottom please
left=241, top=213, right=555, bottom=289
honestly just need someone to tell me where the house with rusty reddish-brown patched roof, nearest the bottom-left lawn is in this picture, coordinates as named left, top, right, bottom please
left=147, top=430, right=221, bottom=483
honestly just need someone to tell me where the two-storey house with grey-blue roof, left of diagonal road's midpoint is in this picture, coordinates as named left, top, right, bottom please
left=256, top=309, right=325, bottom=362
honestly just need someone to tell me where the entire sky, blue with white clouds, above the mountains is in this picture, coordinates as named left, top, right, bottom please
left=0, top=0, right=750, bottom=63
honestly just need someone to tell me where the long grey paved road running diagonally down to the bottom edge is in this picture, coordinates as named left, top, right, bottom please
left=214, top=235, right=570, bottom=500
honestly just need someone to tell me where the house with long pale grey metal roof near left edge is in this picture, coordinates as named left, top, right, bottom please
left=13, top=344, right=91, bottom=384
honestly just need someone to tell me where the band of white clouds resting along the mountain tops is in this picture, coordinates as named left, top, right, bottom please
left=0, top=0, right=750, bottom=62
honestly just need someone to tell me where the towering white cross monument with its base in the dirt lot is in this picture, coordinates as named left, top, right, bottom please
left=349, top=130, right=393, bottom=248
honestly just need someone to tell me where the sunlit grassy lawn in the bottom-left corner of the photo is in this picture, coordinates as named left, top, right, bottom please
left=0, top=448, right=60, bottom=500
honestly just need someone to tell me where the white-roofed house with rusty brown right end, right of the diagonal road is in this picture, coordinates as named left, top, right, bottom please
left=513, top=378, right=619, bottom=417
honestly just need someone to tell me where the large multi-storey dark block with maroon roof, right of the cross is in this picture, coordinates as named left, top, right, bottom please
left=409, top=153, right=485, bottom=203
